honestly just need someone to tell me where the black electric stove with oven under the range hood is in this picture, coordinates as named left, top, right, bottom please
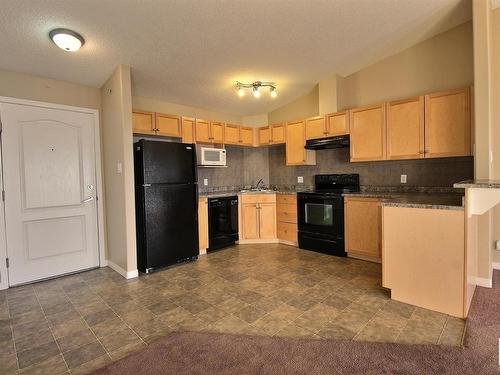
left=297, top=174, right=359, bottom=257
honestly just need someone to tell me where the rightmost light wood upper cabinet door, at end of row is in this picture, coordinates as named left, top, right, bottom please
left=425, top=88, right=471, bottom=158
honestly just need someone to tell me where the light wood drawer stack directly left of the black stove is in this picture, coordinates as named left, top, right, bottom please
left=276, top=194, right=298, bottom=246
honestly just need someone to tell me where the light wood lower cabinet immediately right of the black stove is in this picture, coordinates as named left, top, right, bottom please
left=344, top=197, right=382, bottom=262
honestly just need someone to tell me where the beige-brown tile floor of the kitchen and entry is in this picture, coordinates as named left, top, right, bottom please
left=0, top=245, right=464, bottom=374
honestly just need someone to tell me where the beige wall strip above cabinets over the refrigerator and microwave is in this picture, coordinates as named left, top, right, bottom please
left=132, top=96, right=242, bottom=124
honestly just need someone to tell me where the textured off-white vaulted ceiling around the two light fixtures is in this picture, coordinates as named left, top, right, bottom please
left=0, top=0, right=471, bottom=115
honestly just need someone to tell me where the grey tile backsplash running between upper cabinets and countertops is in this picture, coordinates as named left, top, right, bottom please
left=140, top=137, right=474, bottom=192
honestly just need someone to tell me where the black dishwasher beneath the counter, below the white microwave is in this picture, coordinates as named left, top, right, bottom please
left=208, top=196, right=238, bottom=251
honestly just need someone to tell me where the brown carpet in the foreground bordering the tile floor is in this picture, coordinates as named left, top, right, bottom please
left=96, top=271, right=500, bottom=375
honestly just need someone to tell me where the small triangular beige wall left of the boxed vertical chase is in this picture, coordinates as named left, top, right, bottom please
left=268, top=85, right=319, bottom=124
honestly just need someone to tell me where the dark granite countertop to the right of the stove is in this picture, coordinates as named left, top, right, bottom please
left=344, top=191, right=464, bottom=210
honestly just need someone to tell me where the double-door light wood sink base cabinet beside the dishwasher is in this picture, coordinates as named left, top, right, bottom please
left=239, top=194, right=277, bottom=243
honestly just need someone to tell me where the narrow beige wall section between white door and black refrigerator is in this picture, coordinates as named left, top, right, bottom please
left=101, top=65, right=137, bottom=272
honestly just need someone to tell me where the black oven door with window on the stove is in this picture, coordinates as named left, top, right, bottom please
left=298, top=194, right=344, bottom=238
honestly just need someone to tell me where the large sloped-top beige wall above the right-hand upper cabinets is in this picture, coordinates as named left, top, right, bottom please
left=337, top=22, right=474, bottom=110
